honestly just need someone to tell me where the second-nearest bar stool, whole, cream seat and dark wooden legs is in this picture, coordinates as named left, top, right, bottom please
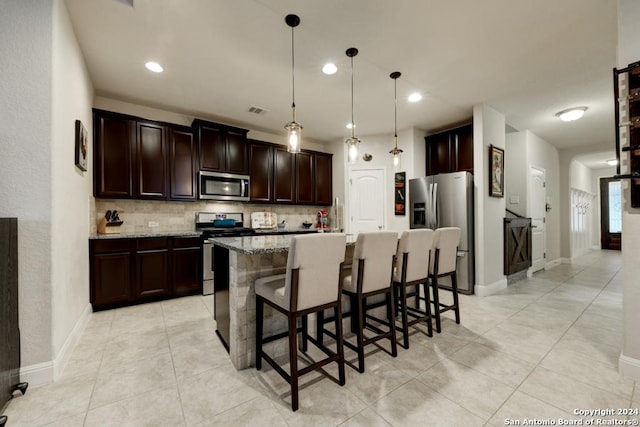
left=336, top=232, right=398, bottom=373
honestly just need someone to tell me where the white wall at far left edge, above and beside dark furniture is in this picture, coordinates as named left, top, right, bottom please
left=0, top=1, right=53, bottom=374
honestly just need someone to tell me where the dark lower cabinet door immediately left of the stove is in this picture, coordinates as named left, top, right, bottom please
left=172, top=244, right=202, bottom=296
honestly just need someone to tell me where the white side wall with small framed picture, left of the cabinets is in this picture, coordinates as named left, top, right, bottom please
left=51, top=0, right=93, bottom=379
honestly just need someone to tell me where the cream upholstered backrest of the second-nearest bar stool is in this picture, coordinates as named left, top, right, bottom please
left=351, top=231, right=398, bottom=293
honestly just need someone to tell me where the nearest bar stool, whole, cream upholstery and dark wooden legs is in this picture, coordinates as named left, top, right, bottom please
left=255, top=233, right=346, bottom=411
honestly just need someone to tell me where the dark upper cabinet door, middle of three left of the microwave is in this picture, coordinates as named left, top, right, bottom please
left=136, top=122, right=167, bottom=199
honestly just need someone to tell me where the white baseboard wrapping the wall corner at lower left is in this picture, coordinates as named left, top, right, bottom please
left=20, top=304, right=92, bottom=387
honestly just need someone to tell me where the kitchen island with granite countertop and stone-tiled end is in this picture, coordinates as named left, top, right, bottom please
left=211, top=235, right=355, bottom=369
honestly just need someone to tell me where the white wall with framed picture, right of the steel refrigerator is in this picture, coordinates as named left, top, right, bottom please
left=473, top=104, right=509, bottom=296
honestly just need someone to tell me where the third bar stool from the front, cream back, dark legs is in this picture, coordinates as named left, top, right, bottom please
left=393, top=229, right=433, bottom=348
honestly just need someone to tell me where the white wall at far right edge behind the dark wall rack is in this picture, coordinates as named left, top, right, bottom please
left=617, top=0, right=640, bottom=380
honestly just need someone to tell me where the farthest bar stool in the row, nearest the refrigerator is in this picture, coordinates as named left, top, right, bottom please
left=429, top=227, right=461, bottom=333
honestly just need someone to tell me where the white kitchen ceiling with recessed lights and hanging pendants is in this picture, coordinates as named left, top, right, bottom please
left=66, top=0, right=617, bottom=160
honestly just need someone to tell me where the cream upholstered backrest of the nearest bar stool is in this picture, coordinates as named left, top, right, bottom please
left=284, top=233, right=347, bottom=311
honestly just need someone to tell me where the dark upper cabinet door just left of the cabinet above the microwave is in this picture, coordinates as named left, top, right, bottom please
left=169, top=128, right=197, bottom=200
